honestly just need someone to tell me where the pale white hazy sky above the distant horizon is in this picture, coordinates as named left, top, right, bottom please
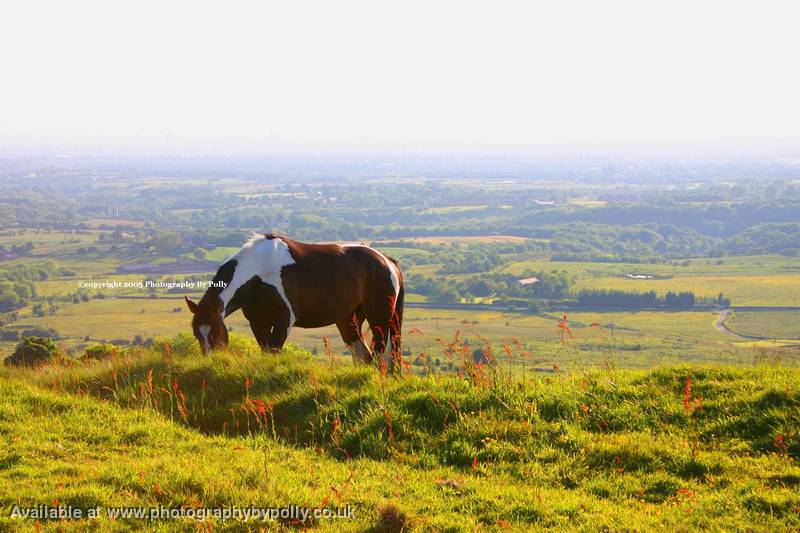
left=0, top=0, right=800, bottom=153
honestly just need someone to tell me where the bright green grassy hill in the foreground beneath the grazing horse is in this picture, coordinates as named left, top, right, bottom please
left=0, top=335, right=800, bottom=531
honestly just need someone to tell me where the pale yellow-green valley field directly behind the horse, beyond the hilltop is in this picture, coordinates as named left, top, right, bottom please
left=7, top=296, right=796, bottom=370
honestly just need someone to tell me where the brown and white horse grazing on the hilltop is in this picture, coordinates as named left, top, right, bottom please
left=184, top=233, right=405, bottom=370
